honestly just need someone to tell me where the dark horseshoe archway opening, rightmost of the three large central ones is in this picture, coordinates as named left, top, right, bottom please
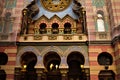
left=67, top=51, right=86, bottom=80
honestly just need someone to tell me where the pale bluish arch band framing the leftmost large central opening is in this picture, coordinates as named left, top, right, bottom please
left=16, top=46, right=41, bottom=66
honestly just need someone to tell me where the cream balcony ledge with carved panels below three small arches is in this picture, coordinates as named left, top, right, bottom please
left=19, top=34, right=87, bottom=42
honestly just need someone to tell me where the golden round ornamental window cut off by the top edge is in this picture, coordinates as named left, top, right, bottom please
left=41, top=0, right=72, bottom=12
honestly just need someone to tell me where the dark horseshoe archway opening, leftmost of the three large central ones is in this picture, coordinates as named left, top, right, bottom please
left=20, top=52, right=37, bottom=80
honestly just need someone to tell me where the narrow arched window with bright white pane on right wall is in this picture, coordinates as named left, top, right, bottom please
left=97, top=11, right=105, bottom=32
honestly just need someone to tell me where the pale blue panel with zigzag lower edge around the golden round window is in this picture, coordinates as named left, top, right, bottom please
left=34, top=0, right=78, bottom=20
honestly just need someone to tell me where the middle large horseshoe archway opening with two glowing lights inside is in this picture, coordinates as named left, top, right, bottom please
left=43, top=51, right=61, bottom=80
